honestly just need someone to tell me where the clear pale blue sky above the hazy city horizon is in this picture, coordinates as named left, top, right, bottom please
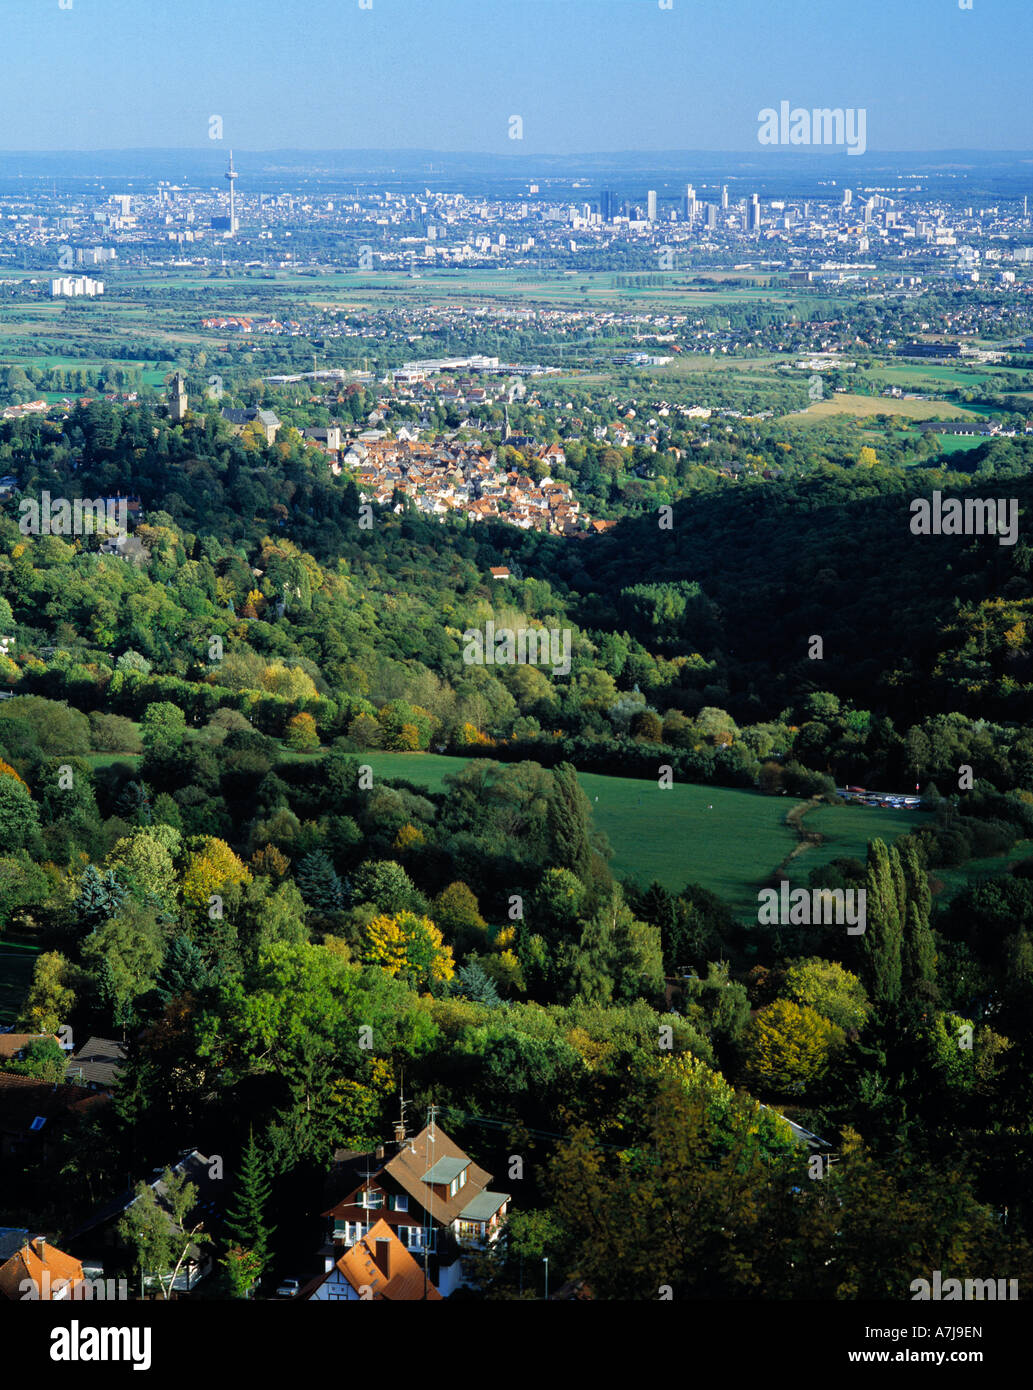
left=8, top=0, right=1033, bottom=154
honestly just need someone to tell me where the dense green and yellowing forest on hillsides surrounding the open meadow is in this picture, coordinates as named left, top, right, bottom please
left=0, top=402, right=1033, bottom=1298
